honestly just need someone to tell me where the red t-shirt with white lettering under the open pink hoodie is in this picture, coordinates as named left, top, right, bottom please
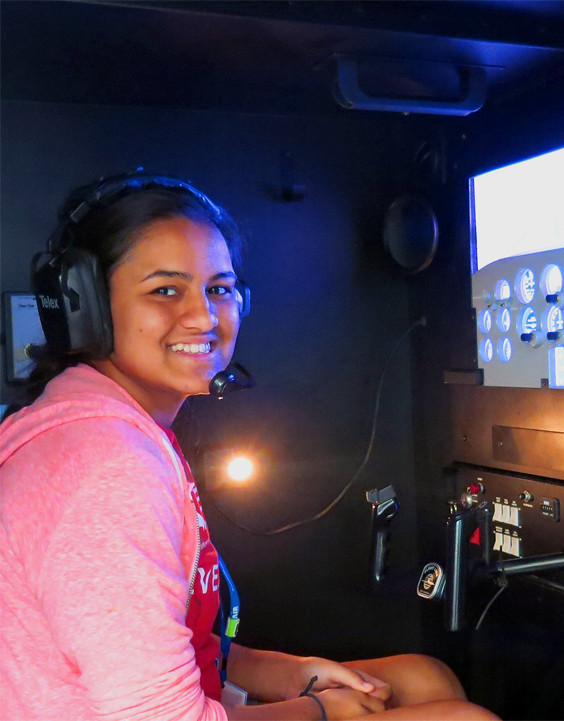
left=163, top=428, right=221, bottom=701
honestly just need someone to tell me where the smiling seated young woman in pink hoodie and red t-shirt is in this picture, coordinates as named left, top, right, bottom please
left=0, top=173, right=497, bottom=721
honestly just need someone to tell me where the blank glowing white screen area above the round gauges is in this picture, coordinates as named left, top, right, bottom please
left=470, top=148, right=564, bottom=273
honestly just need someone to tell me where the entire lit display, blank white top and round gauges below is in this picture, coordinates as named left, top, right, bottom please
left=470, top=143, right=564, bottom=389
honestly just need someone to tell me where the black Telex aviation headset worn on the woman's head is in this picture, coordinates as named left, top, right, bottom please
left=32, top=168, right=250, bottom=358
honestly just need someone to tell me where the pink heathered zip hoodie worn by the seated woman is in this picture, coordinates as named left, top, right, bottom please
left=0, top=365, right=227, bottom=721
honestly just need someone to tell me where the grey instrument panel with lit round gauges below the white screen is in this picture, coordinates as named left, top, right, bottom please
left=472, top=248, right=564, bottom=388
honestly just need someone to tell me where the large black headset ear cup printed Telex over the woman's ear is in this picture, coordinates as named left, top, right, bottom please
left=33, top=247, right=113, bottom=358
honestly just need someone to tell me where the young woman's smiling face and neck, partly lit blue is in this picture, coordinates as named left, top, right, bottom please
left=93, top=217, right=239, bottom=425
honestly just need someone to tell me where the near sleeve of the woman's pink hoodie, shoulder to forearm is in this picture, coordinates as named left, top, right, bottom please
left=33, top=419, right=227, bottom=721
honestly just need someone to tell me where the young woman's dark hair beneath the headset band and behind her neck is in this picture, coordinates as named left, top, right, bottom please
left=4, top=184, right=243, bottom=418
